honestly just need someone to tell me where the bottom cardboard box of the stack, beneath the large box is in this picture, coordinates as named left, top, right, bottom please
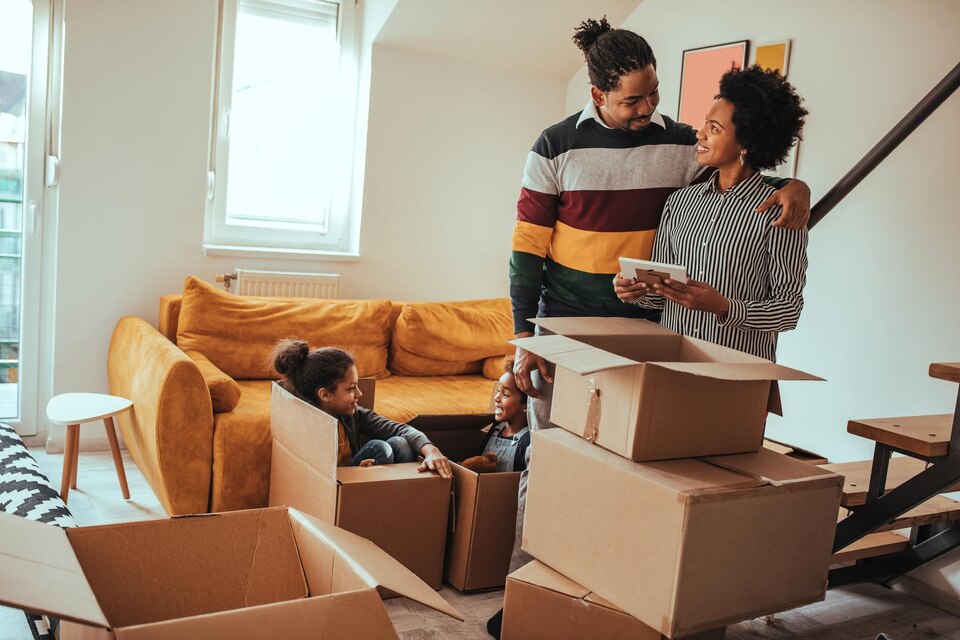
left=500, top=560, right=726, bottom=640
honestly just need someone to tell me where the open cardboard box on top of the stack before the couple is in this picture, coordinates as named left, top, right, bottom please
left=512, top=318, right=820, bottom=461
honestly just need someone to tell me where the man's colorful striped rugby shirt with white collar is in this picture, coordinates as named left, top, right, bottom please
left=510, top=102, right=701, bottom=332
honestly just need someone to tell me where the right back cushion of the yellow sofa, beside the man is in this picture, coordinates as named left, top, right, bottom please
left=390, top=298, right=513, bottom=376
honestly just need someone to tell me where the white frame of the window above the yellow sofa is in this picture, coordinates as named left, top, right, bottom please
left=203, top=0, right=360, bottom=260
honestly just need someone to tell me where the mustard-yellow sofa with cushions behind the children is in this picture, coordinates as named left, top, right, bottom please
left=108, top=277, right=512, bottom=515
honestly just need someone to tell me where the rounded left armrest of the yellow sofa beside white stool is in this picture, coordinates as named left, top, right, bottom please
left=107, top=316, right=213, bottom=515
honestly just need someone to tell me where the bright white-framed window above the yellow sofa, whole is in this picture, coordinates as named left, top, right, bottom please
left=204, top=0, right=357, bottom=254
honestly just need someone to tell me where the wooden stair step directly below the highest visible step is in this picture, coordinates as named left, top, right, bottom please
left=847, top=413, right=953, bottom=457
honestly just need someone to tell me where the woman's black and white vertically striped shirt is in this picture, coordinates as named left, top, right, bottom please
left=636, top=172, right=807, bottom=360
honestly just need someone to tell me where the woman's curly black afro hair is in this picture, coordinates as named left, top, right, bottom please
left=717, top=65, right=807, bottom=170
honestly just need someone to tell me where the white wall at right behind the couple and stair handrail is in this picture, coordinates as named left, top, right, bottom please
left=600, top=0, right=960, bottom=597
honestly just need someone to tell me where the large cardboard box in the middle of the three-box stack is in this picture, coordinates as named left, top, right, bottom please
left=523, top=429, right=843, bottom=638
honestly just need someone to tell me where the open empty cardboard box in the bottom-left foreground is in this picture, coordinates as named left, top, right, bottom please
left=0, top=508, right=463, bottom=640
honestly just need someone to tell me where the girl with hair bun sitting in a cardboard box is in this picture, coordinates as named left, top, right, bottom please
left=273, top=340, right=451, bottom=478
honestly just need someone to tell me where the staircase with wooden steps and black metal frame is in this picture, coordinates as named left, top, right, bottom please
left=823, top=362, right=960, bottom=588
